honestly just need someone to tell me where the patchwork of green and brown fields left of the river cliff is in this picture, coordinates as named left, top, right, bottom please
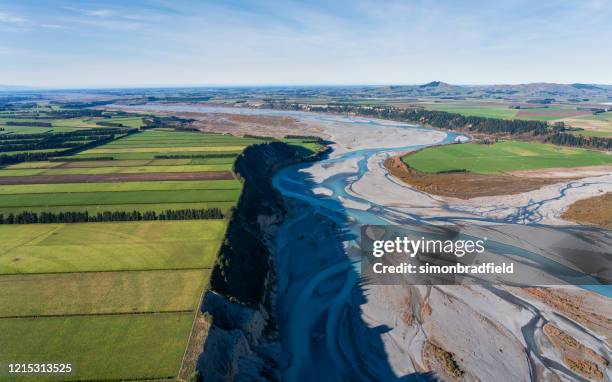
left=0, top=114, right=280, bottom=380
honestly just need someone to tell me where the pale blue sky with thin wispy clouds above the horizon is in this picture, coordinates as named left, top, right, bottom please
left=0, top=0, right=612, bottom=87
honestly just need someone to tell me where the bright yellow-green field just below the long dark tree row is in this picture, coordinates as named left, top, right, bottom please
left=0, top=220, right=227, bottom=274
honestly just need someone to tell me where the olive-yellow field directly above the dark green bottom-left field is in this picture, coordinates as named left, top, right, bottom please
left=0, top=269, right=210, bottom=317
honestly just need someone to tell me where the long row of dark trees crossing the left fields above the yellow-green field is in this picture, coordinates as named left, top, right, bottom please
left=0, top=208, right=225, bottom=224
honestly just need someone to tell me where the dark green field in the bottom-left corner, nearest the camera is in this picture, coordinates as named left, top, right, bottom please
left=0, top=312, right=194, bottom=382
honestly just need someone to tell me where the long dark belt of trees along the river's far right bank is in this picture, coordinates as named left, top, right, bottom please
left=261, top=101, right=612, bottom=150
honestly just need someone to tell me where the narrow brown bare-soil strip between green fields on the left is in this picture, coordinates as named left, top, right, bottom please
left=0, top=171, right=234, bottom=185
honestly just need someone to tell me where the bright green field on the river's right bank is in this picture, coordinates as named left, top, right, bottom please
left=403, top=141, right=612, bottom=174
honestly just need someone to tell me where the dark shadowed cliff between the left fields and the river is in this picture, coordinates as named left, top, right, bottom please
left=197, top=142, right=324, bottom=381
